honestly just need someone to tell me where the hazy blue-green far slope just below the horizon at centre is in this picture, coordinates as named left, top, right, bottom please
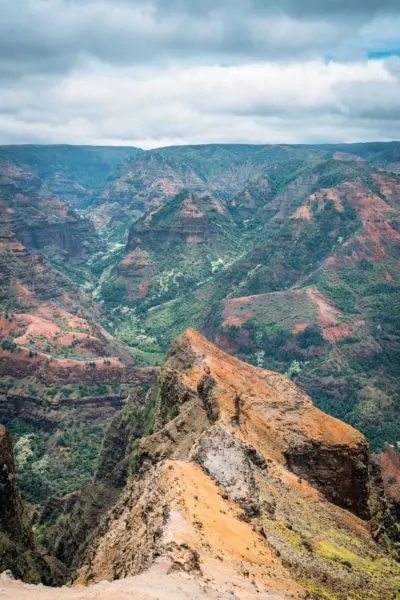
left=89, top=144, right=326, bottom=241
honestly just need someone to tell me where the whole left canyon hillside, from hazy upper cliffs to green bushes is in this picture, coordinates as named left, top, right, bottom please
left=0, top=158, right=156, bottom=503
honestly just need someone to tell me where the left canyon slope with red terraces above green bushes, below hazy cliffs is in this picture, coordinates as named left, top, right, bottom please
left=0, top=200, right=157, bottom=503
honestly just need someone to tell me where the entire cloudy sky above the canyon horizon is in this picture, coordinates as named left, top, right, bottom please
left=0, top=0, right=400, bottom=148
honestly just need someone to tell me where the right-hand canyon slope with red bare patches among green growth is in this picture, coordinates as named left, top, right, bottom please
left=206, top=162, right=400, bottom=447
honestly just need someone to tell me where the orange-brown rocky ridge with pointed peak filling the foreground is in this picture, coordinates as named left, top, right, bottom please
left=0, top=329, right=400, bottom=600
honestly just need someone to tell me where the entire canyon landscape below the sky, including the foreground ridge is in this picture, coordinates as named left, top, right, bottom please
left=0, top=142, right=400, bottom=600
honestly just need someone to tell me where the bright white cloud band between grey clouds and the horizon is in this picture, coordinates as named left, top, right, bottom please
left=0, top=58, right=400, bottom=148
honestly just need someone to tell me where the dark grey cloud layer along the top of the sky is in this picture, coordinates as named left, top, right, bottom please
left=0, top=0, right=400, bottom=78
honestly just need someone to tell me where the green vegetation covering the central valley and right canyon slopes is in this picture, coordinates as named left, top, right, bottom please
left=90, top=148, right=400, bottom=449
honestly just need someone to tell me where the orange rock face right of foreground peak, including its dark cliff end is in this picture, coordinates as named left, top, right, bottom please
left=161, top=330, right=368, bottom=516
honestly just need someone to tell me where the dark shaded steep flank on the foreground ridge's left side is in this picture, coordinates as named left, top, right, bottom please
left=36, top=388, right=152, bottom=571
